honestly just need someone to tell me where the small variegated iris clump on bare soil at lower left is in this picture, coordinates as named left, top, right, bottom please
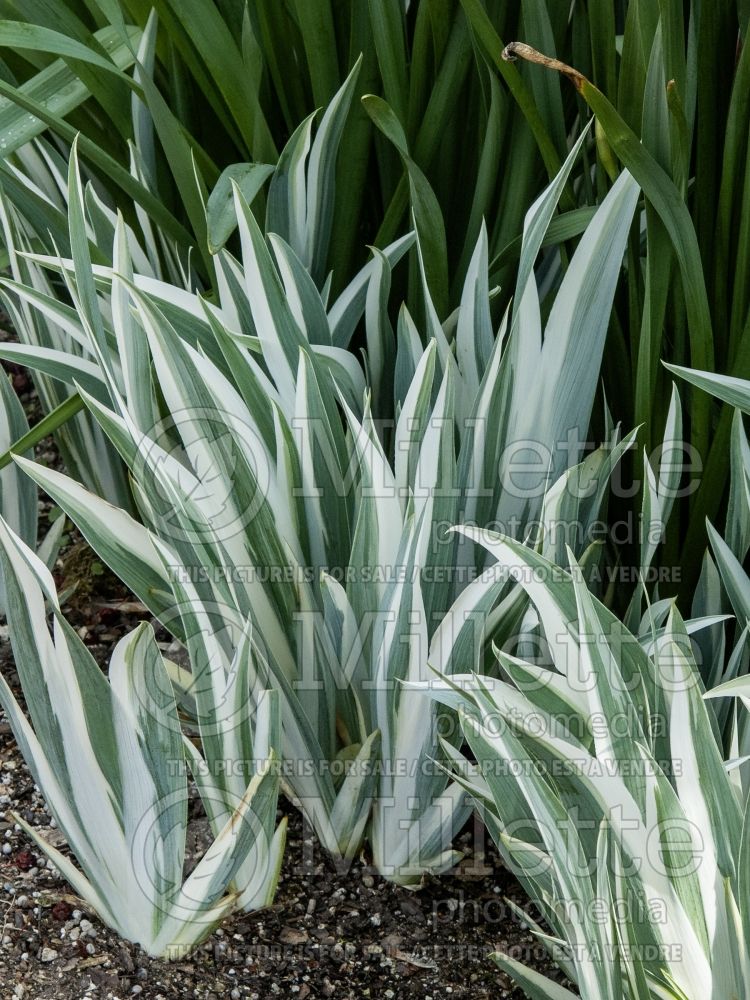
left=0, top=520, right=285, bottom=958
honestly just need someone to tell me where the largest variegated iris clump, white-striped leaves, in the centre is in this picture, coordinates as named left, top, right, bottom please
left=0, top=127, right=638, bottom=884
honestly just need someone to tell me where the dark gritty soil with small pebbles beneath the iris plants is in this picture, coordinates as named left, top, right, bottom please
left=0, top=352, right=569, bottom=1000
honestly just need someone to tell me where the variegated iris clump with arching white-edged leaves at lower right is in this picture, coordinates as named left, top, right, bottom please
left=420, top=531, right=750, bottom=1000
